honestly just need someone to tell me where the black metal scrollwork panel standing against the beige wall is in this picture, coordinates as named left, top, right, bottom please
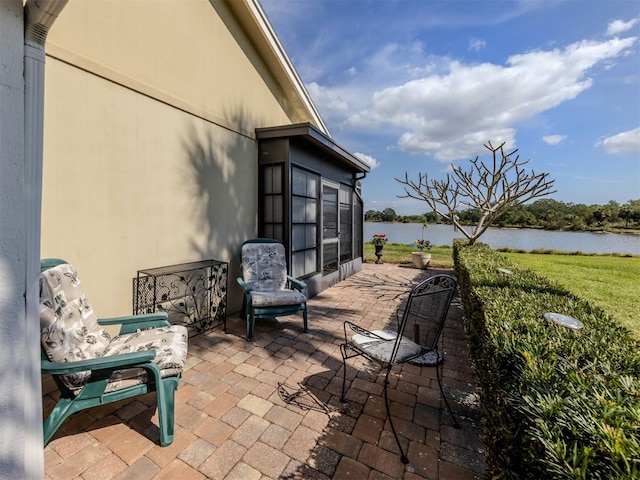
left=134, top=262, right=228, bottom=336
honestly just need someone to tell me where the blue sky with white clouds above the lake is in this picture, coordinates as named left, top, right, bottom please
left=260, top=0, right=640, bottom=215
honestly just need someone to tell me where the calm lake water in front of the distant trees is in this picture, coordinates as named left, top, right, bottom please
left=364, top=222, right=640, bottom=255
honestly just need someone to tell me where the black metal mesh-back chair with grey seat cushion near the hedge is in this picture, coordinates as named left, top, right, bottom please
left=340, top=275, right=459, bottom=464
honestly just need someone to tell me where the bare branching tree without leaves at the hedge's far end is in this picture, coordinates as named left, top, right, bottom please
left=396, top=142, right=556, bottom=244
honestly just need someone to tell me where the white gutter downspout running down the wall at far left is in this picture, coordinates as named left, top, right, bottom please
left=24, top=0, right=67, bottom=479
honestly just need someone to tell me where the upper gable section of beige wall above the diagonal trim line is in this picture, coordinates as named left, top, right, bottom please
left=47, top=0, right=296, bottom=136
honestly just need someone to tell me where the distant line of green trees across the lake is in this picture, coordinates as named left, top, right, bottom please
left=364, top=199, right=640, bottom=230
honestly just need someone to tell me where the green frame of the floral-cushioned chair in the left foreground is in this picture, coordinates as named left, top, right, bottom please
left=40, top=258, right=180, bottom=447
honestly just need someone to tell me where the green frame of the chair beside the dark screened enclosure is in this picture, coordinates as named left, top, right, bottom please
left=237, top=238, right=309, bottom=342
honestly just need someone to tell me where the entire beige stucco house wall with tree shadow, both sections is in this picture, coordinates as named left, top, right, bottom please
left=42, top=0, right=308, bottom=317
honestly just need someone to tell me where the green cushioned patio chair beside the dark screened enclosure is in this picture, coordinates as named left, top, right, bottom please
left=238, top=238, right=309, bottom=342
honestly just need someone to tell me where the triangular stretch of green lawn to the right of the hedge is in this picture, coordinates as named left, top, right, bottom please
left=503, top=253, right=640, bottom=339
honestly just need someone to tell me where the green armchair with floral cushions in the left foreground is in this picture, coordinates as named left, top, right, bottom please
left=40, top=259, right=188, bottom=447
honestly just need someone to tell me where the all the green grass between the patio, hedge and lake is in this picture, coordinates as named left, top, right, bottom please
left=364, top=243, right=640, bottom=339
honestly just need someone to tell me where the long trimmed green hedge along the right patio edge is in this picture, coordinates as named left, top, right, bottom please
left=454, top=241, right=640, bottom=480
